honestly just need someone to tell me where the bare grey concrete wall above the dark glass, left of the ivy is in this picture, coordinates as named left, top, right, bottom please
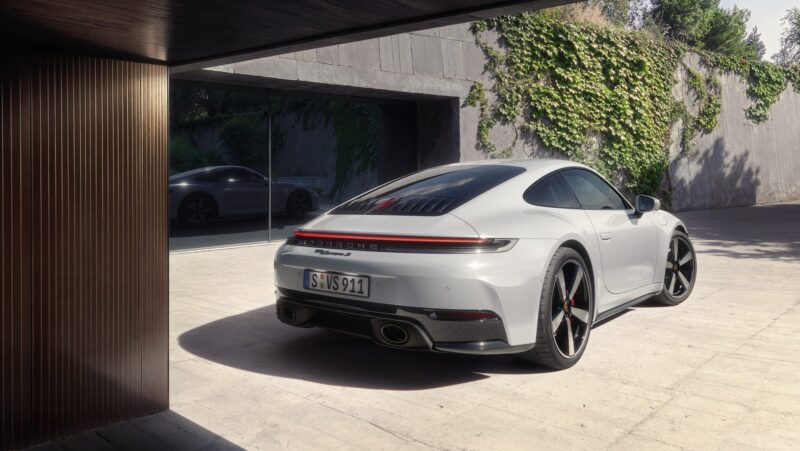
left=197, top=24, right=489, bottom=167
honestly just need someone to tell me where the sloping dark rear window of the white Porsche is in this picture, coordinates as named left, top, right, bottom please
left=331, top=165, right=525, bottom=216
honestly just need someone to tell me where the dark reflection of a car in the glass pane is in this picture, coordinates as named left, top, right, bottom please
left=169, top=166, right=319, bottom=226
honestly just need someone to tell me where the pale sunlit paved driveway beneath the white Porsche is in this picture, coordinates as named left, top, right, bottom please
left=164, top=203, right=800, bottom=449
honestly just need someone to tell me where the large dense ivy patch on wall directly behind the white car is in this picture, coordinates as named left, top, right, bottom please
left=470, top=14, right=682, bottom=193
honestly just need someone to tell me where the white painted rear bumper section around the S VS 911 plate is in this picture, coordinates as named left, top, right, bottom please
left=275, top=240, right=553, bottom=345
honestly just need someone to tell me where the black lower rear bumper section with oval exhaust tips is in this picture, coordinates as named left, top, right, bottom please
left=276, top=289, right=533, bottom=355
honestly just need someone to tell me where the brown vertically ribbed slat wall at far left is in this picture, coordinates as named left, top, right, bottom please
left=0, top=55, right=168, bottom=448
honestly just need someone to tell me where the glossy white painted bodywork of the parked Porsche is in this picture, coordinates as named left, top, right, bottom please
left=275, top=160, right=686, bottom=354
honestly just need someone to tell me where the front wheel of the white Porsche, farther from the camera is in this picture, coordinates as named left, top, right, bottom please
left=653, top=230, right=697, bottom=306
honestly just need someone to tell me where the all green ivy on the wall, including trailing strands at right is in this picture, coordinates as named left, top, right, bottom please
left=472, top=13, right=800, bottom=200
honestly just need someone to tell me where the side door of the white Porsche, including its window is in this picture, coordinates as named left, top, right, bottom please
left=561, top=169, right=658, bottom=298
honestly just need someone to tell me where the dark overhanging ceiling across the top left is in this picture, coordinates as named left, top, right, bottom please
left=0, top=0, right=571, bottom=69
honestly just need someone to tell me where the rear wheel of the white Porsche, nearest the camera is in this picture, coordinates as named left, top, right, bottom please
left=517, top=247, right=594, bottom=370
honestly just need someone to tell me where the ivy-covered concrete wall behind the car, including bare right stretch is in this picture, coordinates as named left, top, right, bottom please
left=464, top=14, right=800, bottom=209
